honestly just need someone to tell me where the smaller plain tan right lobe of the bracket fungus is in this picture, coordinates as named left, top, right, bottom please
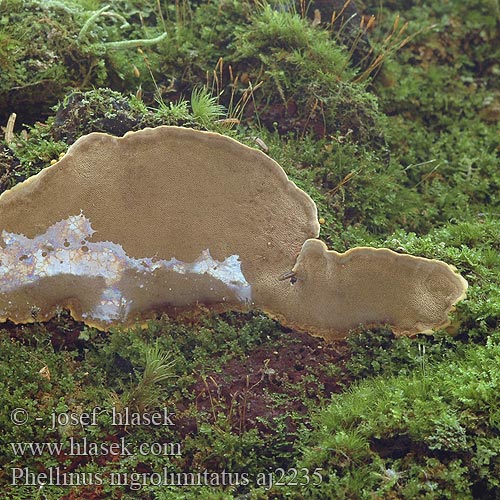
left=268, top=239, right=467, bottom=340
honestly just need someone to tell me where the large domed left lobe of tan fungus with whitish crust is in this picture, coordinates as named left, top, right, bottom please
left=0, top=127, right=319, bottom=329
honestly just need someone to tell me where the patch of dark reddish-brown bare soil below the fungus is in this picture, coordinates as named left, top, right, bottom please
left=177, top=332, right=351, bottom=435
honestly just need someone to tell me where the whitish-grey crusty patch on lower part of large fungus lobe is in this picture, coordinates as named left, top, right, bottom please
left=0, top=214, right=251, bottom=327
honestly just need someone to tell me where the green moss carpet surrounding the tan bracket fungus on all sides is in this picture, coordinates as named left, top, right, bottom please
left=0, top=0, right=500, bottom=499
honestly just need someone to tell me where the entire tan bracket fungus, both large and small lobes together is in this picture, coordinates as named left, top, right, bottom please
left=0, top=126, right=467, bottom=339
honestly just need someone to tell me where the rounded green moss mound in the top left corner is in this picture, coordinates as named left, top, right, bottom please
left=0, top=1, right=106, bottom=121
